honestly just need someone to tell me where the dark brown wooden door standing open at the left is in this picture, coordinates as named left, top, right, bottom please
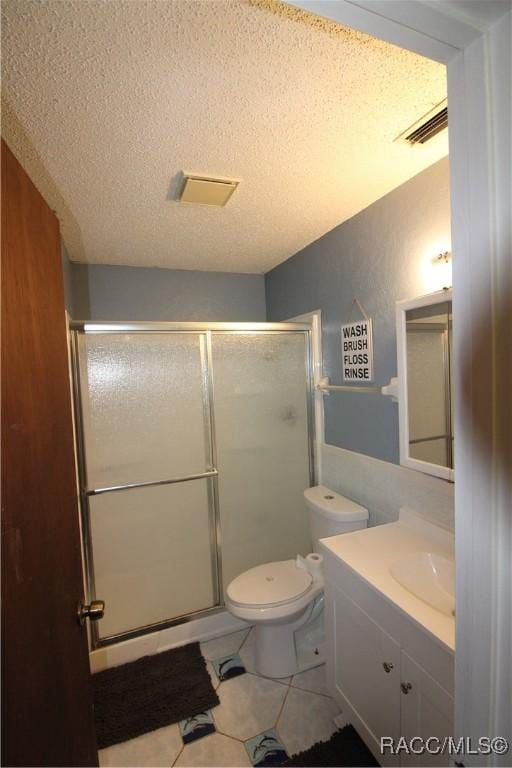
left=2, top=142, right=98, bottom=766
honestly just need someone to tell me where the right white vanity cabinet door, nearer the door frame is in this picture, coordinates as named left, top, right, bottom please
left=400, top=651, right=453, bottom=766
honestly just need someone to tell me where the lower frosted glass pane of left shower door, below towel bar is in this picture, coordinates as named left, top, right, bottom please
left=90, top=479, right=216, bottom=637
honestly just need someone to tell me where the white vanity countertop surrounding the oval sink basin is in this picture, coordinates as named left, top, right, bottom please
left=321, top=509, right=455, bottom=651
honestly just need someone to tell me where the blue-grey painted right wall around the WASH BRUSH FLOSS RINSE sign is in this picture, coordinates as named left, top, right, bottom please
left=265, top=158, right=450, bottom=463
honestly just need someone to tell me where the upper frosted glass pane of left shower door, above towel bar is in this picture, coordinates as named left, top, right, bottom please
left=79, top=333, right=211, bottom=489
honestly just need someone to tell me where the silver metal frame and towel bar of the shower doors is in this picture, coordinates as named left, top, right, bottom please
left=69, top=321, right=316, bottom=650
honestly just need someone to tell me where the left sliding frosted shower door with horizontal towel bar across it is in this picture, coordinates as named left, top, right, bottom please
left=77, top=333, right=218, bottom=637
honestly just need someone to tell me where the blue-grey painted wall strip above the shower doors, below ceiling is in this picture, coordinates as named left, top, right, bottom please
left=64, top=263, right=265, bottom=322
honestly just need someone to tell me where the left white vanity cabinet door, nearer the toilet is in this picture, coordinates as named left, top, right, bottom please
left=333, top=589, right=400, bottom=764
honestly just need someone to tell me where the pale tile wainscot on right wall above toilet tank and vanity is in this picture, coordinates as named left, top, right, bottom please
left=321, top=443, right=454, bottom=530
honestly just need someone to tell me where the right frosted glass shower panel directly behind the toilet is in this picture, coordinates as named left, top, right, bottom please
left=212, top=332, right=310, bottom=586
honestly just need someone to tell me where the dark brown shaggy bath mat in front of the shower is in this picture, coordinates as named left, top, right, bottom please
left=92, top=643, right=219, bottom=749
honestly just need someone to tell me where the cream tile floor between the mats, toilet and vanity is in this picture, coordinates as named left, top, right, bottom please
left=99, top=629, right=339, bottom=768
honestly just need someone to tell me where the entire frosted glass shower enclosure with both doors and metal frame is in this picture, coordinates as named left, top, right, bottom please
left=71, top=322, right=314, bottom=648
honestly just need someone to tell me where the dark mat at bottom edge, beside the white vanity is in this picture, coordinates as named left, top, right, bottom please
left=282, top=725, right=379, bottom=768
